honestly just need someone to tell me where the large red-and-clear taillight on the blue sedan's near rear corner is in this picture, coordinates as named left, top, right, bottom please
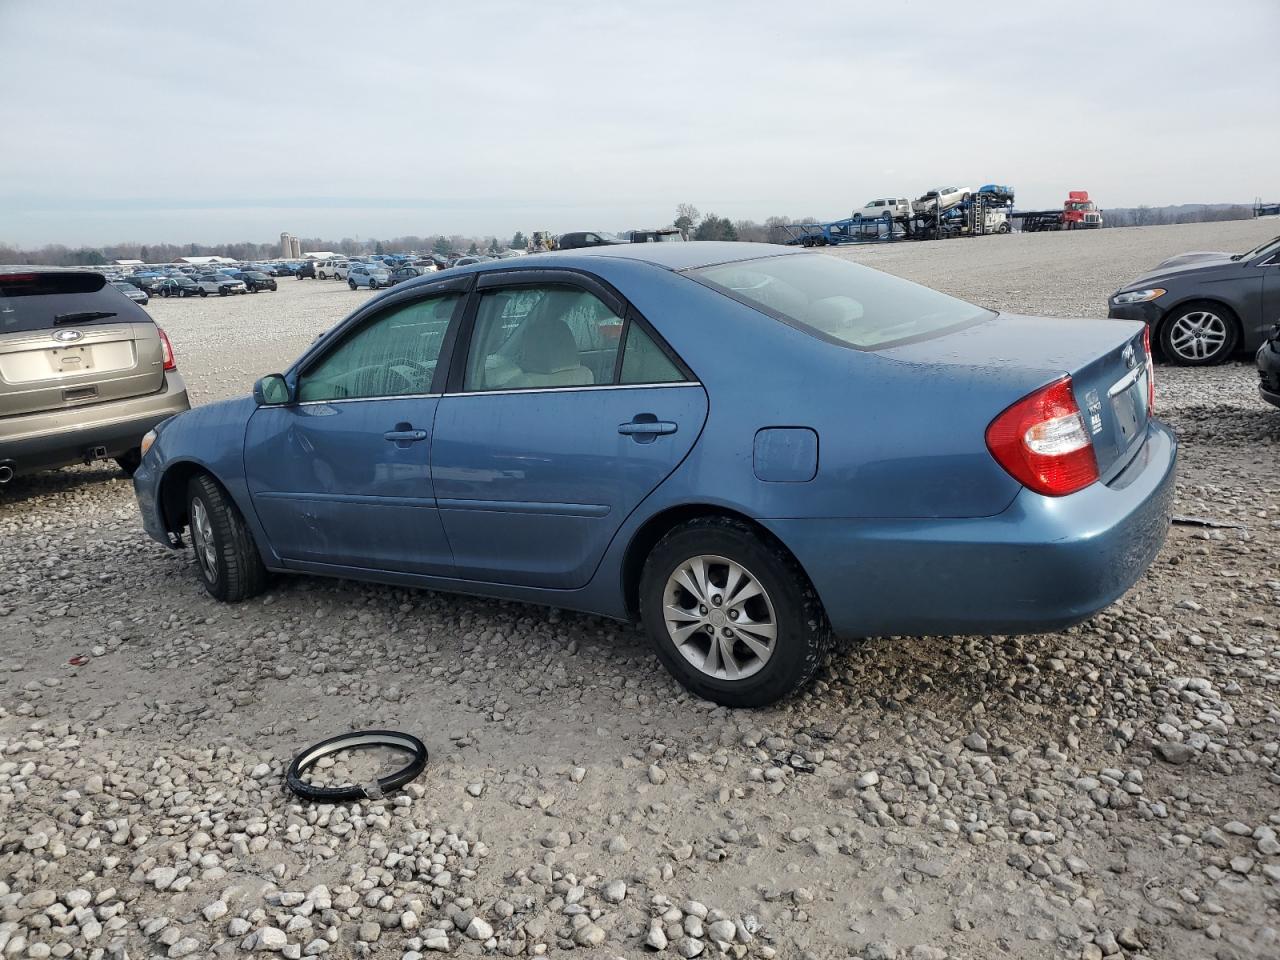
left=987, top=376, right=1098, bottom=497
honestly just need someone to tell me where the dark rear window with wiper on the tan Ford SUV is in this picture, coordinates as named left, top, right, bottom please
left=0, top=271, right=151, bottom=337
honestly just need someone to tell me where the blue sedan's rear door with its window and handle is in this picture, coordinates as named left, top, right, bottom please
left=431, top=270, right=707, bottom=589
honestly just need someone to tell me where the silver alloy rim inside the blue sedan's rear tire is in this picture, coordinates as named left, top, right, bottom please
left=663, top=556, right=778, bottom=680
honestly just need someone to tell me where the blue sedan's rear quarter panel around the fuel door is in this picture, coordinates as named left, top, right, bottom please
left=593, top=255, right=1029, bottom=518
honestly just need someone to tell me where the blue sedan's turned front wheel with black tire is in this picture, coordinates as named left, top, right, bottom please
left=187, top=474, right=266, bottom=603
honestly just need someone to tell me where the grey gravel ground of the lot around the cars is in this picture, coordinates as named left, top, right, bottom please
left=0, top=223, right=1280, bottom=960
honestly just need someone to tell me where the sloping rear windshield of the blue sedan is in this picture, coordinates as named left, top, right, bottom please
left=689, top=253, right=995, bottom=349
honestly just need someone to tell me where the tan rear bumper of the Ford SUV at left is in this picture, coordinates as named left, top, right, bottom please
left=0, top=371, right=191, bottom=474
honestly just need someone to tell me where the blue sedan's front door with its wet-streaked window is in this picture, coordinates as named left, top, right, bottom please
left=244, top=278, right=468, bottom=576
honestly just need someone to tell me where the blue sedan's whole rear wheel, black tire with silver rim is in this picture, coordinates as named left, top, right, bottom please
left=640, top=517, right=831, bottom=707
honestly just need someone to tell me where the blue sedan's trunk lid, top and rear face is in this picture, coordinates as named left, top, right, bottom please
left=878, top=314, right=1151, bottom=483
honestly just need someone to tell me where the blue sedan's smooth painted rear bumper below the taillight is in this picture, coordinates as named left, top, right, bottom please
left=763, top=421, right=1178, bottom=636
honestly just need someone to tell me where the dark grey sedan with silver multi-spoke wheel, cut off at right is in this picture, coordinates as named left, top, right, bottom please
left=1107, top=237, right=1280, bottom=366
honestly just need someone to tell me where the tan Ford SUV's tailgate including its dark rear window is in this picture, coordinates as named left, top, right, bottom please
left=0, top=271, right=164, bottom=417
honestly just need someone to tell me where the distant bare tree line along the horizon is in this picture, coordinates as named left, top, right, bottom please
left=0, top=204, right=1253, bottom=266
